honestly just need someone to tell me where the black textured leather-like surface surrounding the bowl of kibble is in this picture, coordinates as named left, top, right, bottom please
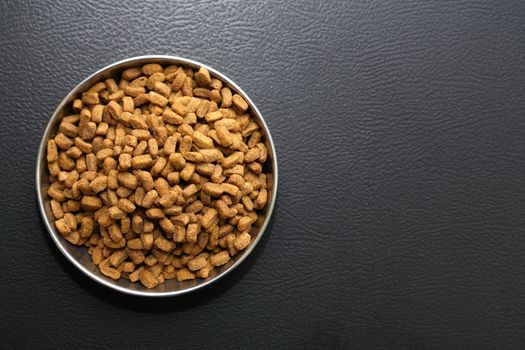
left=0, top=0, right=525, bottom=349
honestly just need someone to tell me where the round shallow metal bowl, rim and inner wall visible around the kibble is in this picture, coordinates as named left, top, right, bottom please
left=36, top=55, right=277, bottom=297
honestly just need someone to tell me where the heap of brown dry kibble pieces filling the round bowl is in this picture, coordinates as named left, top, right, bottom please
left=47, top=63, right=269, bottom=288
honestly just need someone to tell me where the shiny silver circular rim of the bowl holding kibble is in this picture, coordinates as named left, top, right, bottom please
left=35, top=55, right=278, bottom=297
